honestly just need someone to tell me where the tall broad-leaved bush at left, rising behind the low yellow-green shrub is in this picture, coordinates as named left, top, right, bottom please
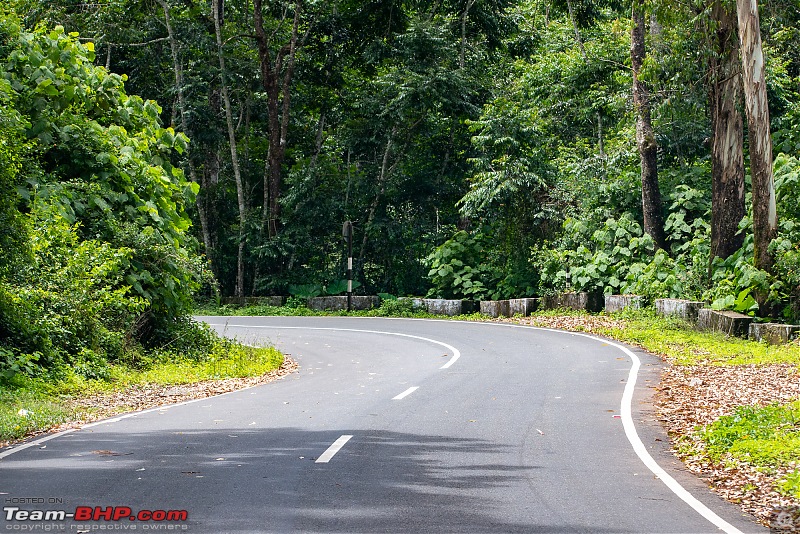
left=0, top=21, right=203, bottom=344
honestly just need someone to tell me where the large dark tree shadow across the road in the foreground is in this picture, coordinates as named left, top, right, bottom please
left=0, top=428, right=619, bottom=533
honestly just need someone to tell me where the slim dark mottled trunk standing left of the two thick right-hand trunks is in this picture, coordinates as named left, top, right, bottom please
left=631, top=0, right=667, bottom=249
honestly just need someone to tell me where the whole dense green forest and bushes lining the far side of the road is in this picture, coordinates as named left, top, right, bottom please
left=0, top=0, right=800, bottom=376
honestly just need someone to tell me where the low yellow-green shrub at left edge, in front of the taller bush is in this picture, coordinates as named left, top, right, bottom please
left=0, top=211, right=146, bottom=378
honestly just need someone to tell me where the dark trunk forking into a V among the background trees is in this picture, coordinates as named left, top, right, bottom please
left=253, top=0, right=301, bottom=237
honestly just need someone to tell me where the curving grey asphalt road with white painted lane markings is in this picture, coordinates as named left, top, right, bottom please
left=0, top=317, right=767, bottom=533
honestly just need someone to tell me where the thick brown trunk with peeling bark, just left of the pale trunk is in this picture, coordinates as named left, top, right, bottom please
left=709, top=0, right=745, bottom=261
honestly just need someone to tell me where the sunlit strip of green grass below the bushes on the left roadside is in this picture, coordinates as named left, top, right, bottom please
left=0, top=340, right=283, bottom=442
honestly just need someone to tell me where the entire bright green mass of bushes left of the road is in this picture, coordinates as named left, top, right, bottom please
left=0, top=12, right=218, bottom=381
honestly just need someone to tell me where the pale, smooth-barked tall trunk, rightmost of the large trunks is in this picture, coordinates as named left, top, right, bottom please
left=736, top=0, right=778, bottom=271
